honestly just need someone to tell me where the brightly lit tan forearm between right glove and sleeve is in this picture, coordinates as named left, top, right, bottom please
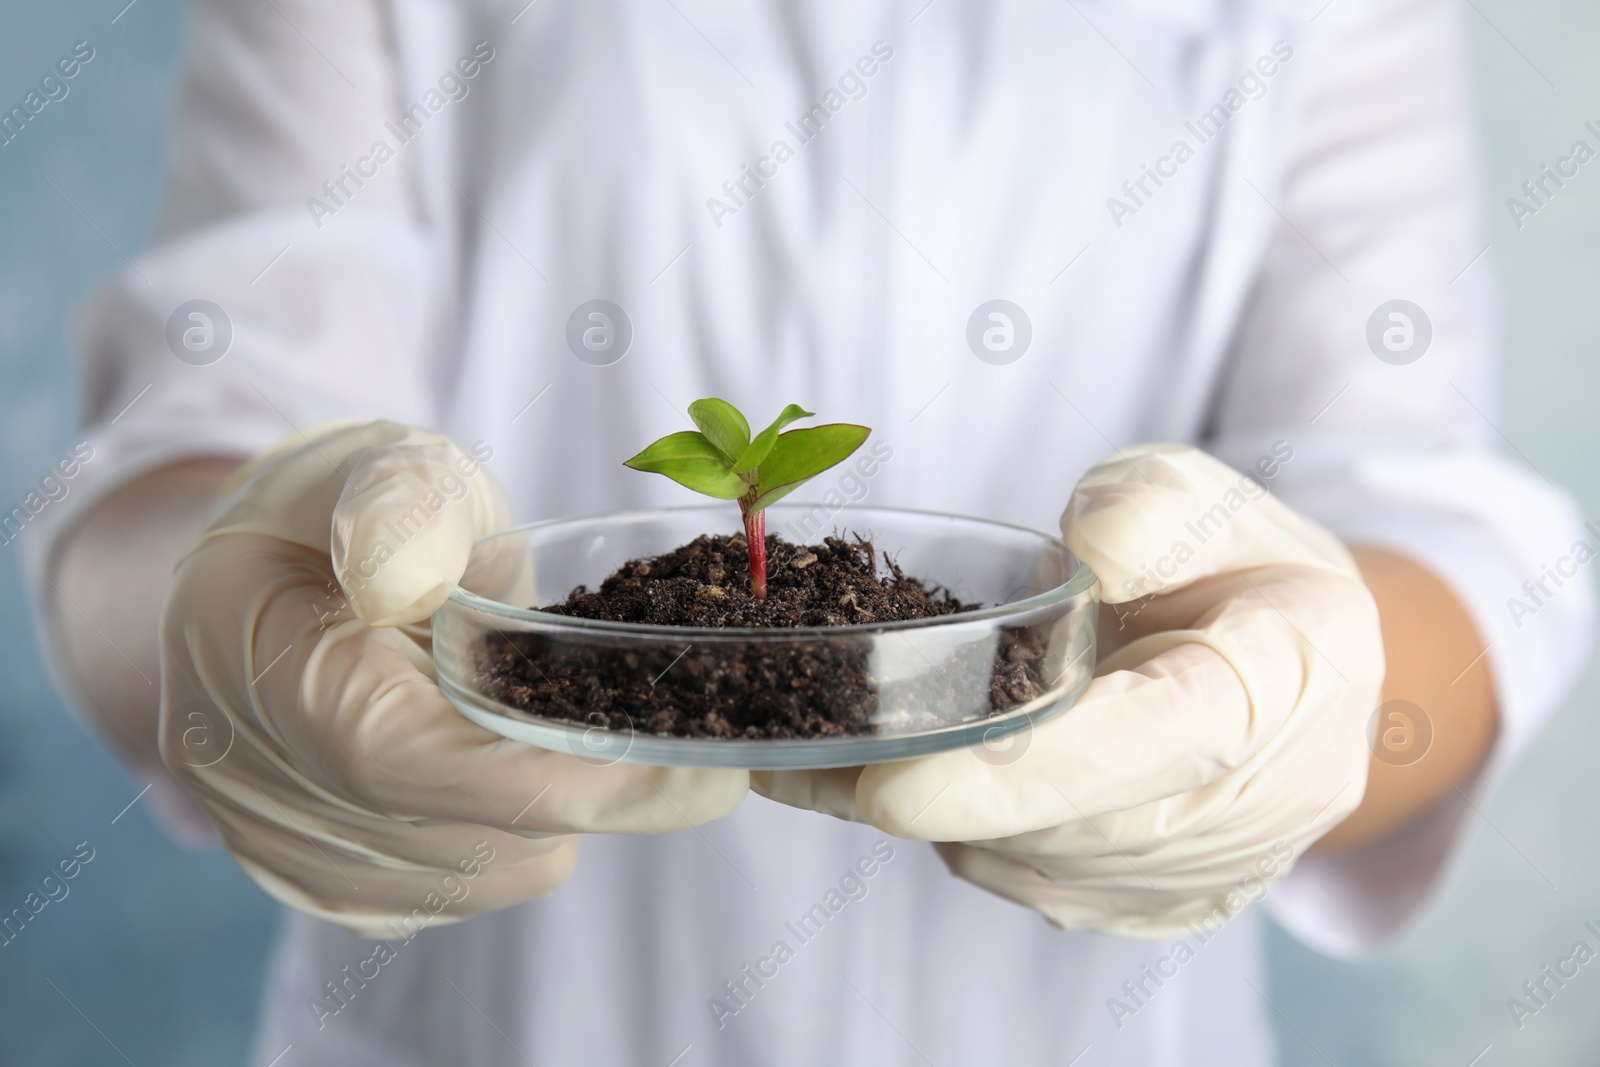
left=1318, top=545, right=1499, bottom=851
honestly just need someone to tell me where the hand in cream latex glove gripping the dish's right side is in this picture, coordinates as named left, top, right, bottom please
left=752, top=445, right=1384, bottom=937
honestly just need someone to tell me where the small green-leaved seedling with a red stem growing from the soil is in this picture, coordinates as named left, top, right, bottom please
left=626, top=397, right=872, bottom=600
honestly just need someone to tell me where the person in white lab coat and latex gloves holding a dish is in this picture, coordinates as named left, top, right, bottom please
left=26, top=0, right=1590, bottom=1067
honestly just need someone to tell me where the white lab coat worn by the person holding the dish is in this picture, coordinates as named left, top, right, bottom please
left=29, top=0, right=1595, bottom=1067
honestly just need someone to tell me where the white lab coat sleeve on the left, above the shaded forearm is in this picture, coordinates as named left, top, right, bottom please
left=21, top=0, right=448, bottom=831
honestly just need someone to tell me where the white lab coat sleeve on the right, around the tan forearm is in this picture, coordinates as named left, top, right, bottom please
left=1208, top=0, right=1600, bottom=955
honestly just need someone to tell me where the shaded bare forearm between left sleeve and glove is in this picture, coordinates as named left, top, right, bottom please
left=48, top=458, right=237, bottom=768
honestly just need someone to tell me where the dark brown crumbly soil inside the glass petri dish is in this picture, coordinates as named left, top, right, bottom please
left=478, top=536, right=1048, bottom=739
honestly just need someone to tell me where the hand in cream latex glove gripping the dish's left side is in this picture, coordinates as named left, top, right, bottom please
left=162, top=422, right=747, bottom=937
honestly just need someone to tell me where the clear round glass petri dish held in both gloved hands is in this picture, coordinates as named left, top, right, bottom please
left=434, top=504, right=1099, bottom=769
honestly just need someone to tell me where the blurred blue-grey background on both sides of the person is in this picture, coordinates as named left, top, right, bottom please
left=0, top=0, right=1600, bottom=1067
